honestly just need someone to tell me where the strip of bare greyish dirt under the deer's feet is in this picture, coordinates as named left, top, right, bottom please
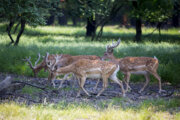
left=0, top=73, right=180, bottom=105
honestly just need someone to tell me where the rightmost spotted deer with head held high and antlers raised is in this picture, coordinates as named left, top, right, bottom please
left=102, top=39, right=165, bottom=93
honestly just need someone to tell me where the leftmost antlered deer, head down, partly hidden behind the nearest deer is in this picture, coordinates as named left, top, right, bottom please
left=24, top=53, right=100, bottom=89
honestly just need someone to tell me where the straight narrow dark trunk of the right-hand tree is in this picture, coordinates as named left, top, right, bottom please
left=135, top=18, right=142, bottom=42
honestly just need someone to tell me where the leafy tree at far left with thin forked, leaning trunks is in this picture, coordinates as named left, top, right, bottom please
left=0, top=0, right=59, bottom=45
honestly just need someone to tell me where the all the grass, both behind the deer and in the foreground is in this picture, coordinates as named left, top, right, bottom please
left=0, top=23, right=180, bottom=120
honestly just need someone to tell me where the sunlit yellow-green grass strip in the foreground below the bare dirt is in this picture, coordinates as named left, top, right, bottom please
left=0, top=99, right=180, bottom=120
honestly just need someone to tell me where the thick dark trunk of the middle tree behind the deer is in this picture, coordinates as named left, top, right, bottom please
left=86, top=17, right=96, bottom=37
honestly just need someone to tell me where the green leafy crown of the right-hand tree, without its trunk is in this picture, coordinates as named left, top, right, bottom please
left=132, top=0, right=173, bottom=22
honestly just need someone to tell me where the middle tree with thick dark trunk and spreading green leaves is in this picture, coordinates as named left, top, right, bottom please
left=78, top=0, right=127, bottom=40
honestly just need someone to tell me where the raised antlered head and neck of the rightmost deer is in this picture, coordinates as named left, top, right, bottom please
left=101, top=39, right=121, bottom=60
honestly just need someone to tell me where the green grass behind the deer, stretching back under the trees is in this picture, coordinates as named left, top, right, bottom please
left=0, top=24, right=180, bottom=84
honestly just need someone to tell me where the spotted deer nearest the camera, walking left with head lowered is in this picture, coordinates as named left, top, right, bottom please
left=46, top=53, right=125, bottom=97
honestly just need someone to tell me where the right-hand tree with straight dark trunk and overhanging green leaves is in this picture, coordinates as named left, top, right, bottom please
left=132, top=0, right=173, bottom=42
